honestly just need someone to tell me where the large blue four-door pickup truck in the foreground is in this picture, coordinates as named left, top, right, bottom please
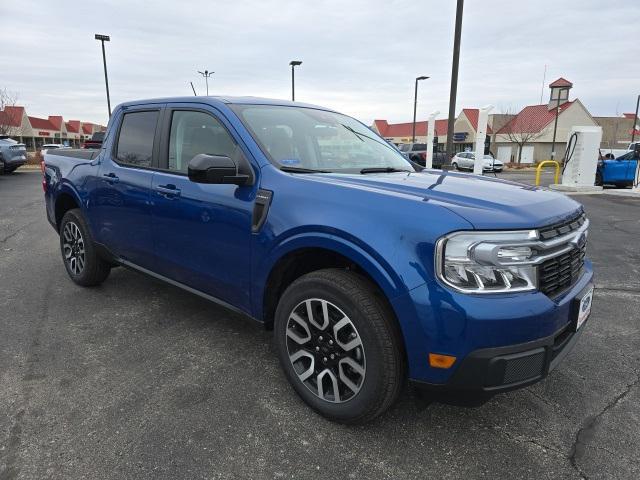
left=43, top=97, right=593, bottom=423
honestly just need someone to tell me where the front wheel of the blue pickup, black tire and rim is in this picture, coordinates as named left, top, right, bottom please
left=274, top=269, right=405, bottom=424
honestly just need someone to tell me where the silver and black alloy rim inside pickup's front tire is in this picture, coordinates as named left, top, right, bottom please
left=286, top=298, right=366, bottom=403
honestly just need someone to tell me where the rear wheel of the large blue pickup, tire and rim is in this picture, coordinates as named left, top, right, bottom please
left=60, top=208, right=111, bottom=287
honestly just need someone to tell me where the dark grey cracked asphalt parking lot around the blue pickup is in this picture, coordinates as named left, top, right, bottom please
left=0, top=171, right=640, bottom=480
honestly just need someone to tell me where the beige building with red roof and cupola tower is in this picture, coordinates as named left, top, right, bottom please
left=492, top=77, right=598, bottom=163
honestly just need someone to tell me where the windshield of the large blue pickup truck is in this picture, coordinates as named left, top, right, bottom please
left=233, top=105, right=413, bottom=173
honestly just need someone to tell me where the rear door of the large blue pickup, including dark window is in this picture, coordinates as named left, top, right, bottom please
left=90, top=106, right=162, bottom=269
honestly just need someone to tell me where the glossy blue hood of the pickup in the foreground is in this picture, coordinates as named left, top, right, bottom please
left=309, top=170, right=582, bottom=230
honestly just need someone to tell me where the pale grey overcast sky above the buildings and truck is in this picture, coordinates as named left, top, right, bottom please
left=0, top=0, right=640, bottom=124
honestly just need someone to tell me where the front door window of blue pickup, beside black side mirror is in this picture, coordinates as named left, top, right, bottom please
left=169, top=111, right=236, bottom=173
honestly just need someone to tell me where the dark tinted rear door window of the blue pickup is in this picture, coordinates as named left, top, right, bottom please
left=116, top=111, right=158, bottom=167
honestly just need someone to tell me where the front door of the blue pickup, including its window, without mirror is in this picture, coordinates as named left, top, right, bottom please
left=151, top=104, right=257, bottom=310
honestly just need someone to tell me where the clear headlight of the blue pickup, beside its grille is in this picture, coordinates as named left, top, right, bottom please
left=436, top=230, right=538, bottom=293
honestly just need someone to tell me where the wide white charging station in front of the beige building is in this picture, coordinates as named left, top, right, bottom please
left=549, top=126, right=602, bottom=192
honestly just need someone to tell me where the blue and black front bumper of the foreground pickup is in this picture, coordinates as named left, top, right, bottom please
left=392, top=260, right=593, bottom=392
